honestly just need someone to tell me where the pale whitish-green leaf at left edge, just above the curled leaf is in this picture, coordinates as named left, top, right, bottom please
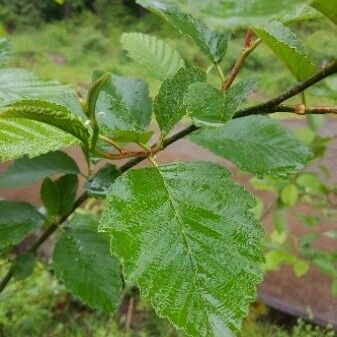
left=0, top=68, right=70, bottom=107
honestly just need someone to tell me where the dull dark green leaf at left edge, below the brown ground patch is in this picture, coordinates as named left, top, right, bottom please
left=0, top=200, right=44, bottom=248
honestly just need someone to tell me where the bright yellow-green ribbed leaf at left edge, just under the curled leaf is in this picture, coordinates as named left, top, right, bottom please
left=0, top=118, right=79, bottom=161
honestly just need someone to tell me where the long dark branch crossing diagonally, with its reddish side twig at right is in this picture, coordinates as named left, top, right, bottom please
left=0, top=60, right=337, bottom=293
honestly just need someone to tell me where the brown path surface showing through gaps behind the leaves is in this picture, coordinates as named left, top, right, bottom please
left=0, top=120, right=337, bottom=328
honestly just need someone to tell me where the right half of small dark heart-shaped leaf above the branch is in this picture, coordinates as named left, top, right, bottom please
left=55, top=174, right=78, bottom=216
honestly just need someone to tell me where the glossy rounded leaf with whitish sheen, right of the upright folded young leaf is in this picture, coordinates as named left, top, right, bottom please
left=96, top=75, right=152, bottom=141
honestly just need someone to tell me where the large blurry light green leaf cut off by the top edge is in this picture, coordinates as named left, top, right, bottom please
left=176, top=0, right=318, bottom=29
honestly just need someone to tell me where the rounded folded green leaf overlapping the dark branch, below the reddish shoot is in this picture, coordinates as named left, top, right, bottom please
left=184, top=79, right=256, bottom=126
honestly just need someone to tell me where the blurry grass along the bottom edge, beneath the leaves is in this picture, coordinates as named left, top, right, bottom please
left=0, top=264, right=336, bottom=337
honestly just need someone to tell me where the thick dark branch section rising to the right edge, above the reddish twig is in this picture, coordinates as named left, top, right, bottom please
left=235, top=60, right=337, bottom=117
